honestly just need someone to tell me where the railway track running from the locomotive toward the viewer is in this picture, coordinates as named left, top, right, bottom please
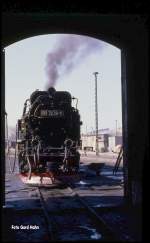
left=37, top=182, right=119, bottom=241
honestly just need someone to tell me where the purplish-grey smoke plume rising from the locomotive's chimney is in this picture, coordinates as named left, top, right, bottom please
left=45, top=35, right=104, bottom=90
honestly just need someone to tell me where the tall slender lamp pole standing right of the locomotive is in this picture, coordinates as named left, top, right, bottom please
left=93, top=72, right=99, bottom=156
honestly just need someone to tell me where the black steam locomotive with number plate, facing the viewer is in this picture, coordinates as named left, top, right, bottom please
left=17, top=87, right=82, bottom=178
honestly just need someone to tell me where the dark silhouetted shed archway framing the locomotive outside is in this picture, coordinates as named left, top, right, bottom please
left=1, top=13, right=148, bottom=205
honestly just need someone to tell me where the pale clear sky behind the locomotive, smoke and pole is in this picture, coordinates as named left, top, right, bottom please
left=5, top=34, right=122, bottom=132
